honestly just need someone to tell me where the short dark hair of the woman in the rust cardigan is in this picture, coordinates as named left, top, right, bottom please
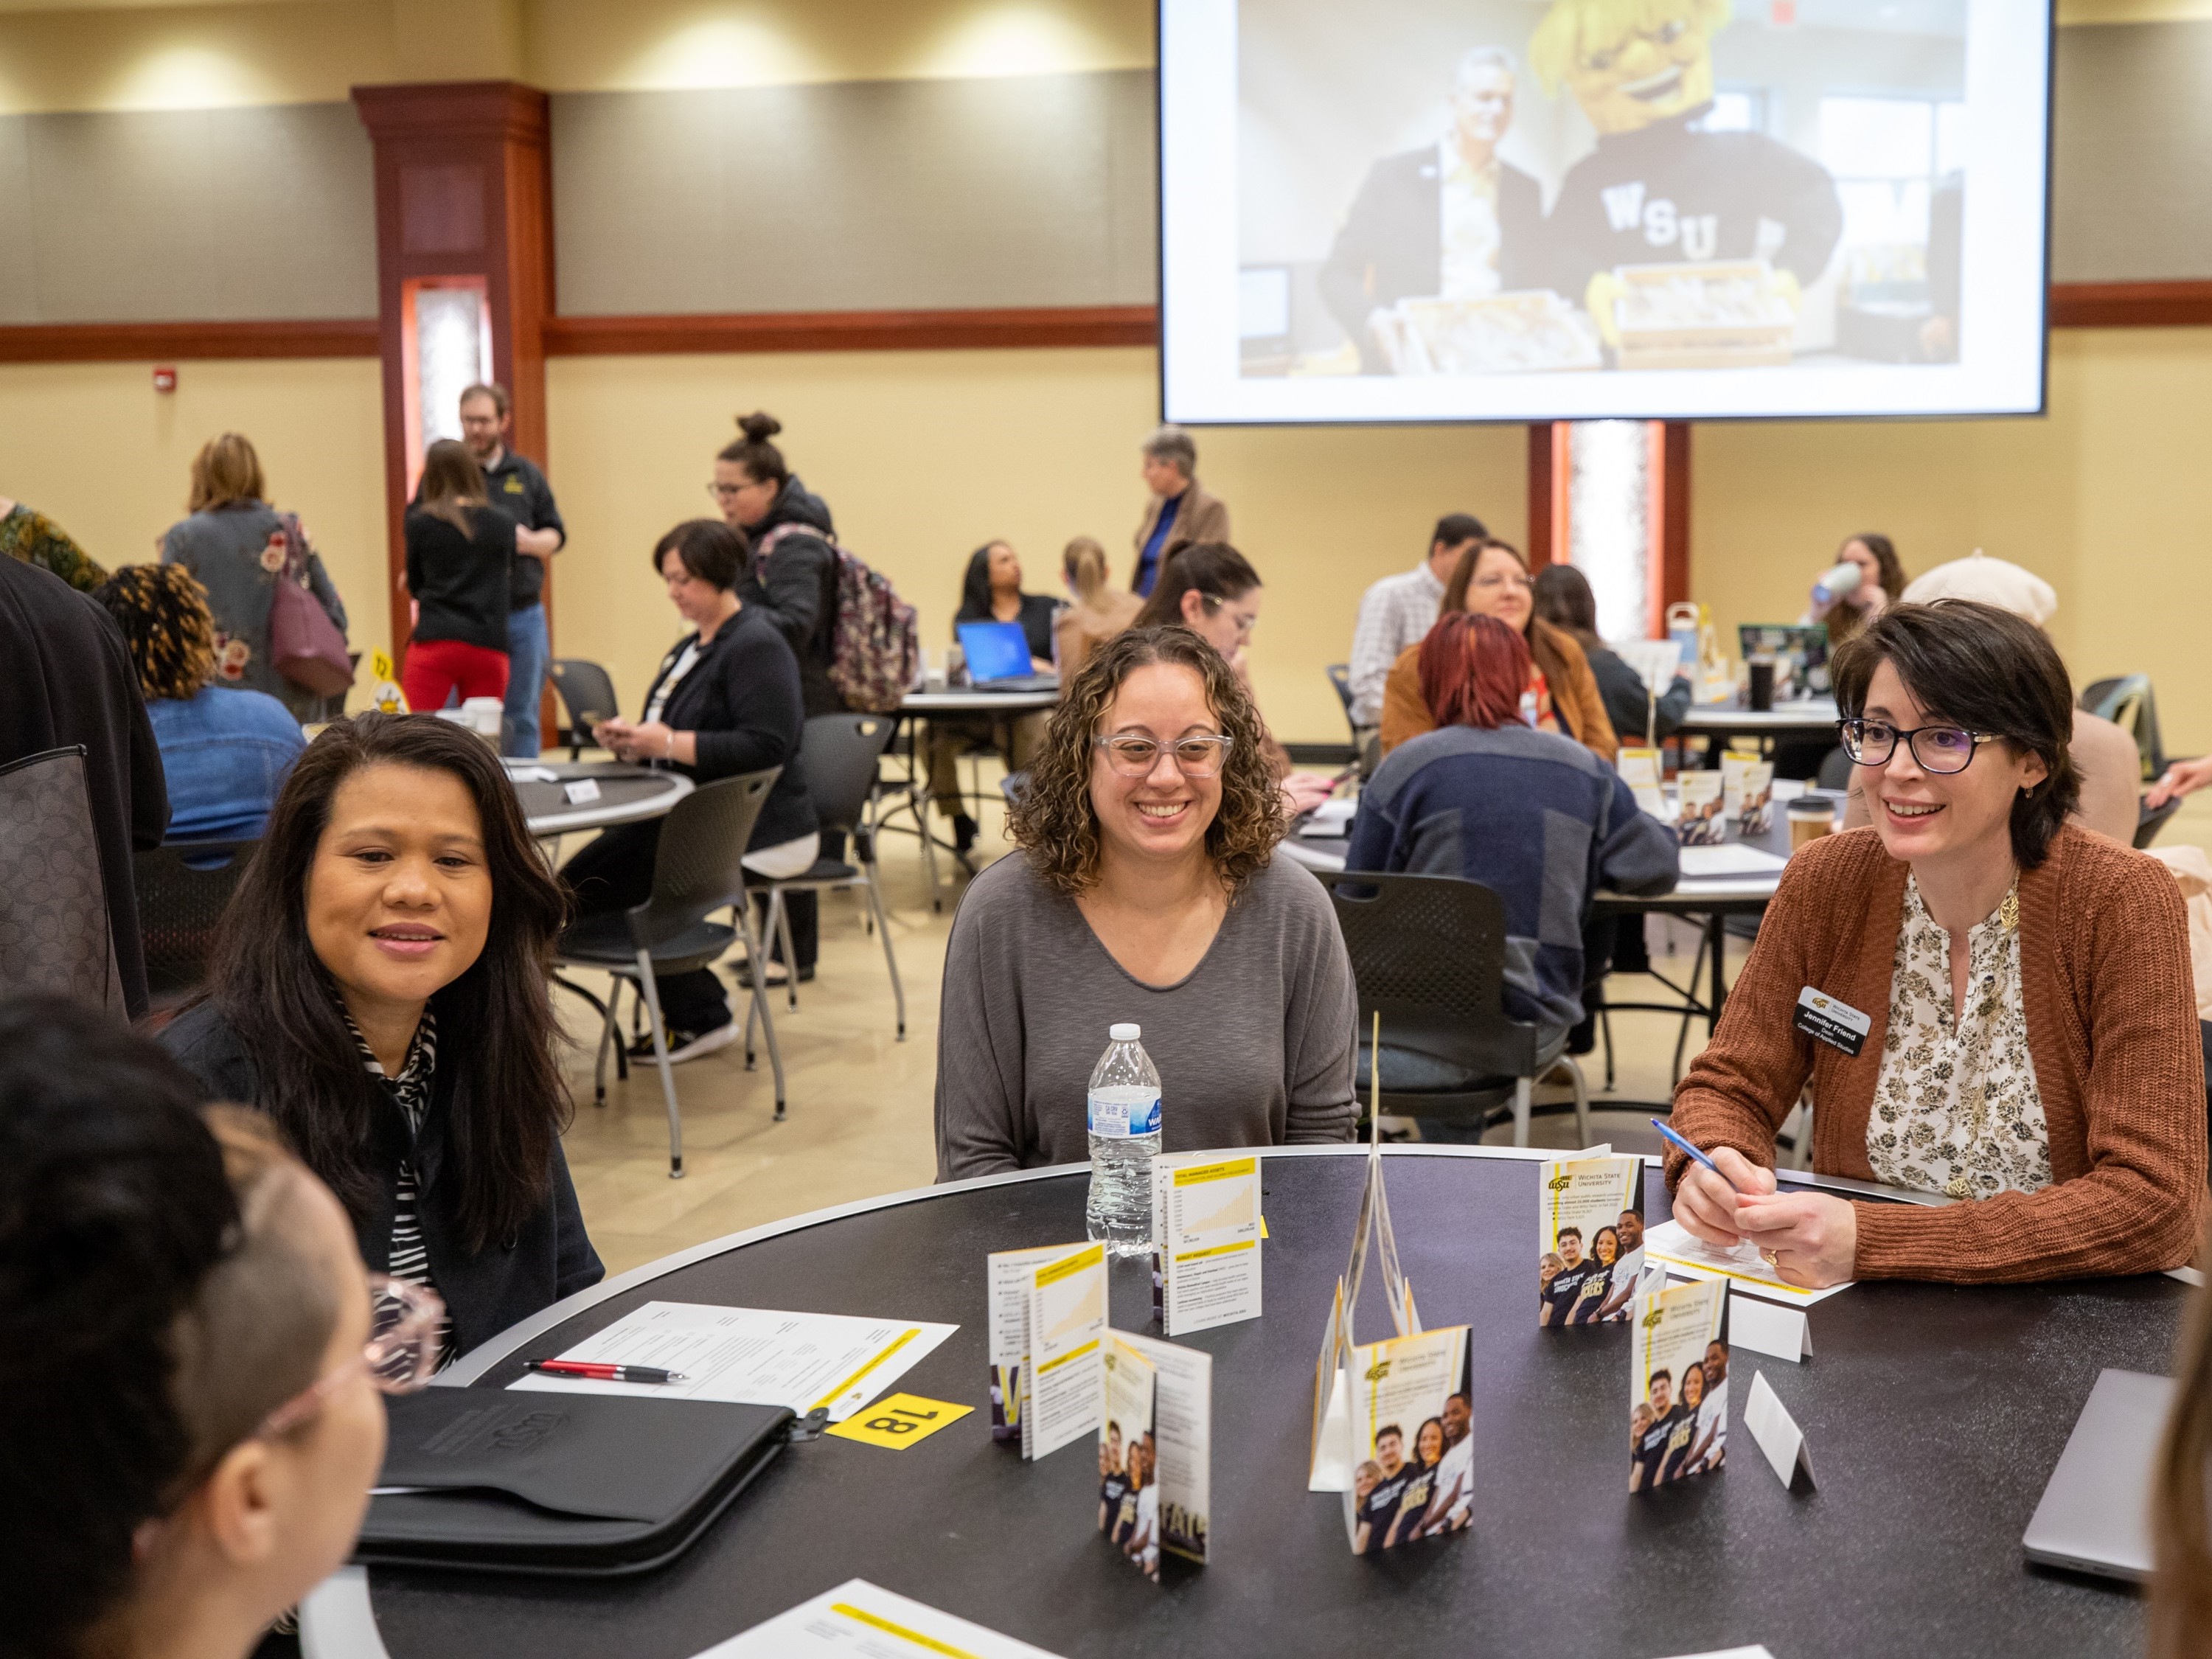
left=1829, top=599, right=2081, bottom=869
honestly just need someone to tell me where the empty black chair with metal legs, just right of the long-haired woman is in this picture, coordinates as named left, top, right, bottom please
left=555, top=768, right=783, bottom=1179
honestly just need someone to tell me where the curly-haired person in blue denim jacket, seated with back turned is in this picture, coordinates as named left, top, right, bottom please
left=93, top=564, right=307, bottom=841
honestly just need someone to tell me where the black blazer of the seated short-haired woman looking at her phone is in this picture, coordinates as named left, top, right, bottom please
left=646, top=606, right=816, bottom=847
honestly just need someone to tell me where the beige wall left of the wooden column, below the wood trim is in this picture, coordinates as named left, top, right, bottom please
left=0, top=358, right=392, bottom=699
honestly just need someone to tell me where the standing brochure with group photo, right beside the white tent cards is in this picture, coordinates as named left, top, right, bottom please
left=1628, top=1279, right=1728, bottom=1493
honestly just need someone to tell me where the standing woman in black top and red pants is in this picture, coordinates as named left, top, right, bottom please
left=400, top=438, right=515, bottom=714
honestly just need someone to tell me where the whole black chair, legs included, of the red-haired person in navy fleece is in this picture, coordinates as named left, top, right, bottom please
left=1325, top=869, right=1590, bottom=1146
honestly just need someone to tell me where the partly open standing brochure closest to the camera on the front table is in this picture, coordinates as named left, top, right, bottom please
left=1097, top=1332, right=1214, bottom=1582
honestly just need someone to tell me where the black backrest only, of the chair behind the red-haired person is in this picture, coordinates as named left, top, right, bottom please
left=1323, top=869, right=1537, bottom=1073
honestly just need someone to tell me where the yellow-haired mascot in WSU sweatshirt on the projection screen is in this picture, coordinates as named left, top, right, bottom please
left=1528, top=0, right=1843, bottom=341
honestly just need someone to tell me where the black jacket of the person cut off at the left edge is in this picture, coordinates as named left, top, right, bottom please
left=0, top=553, right=168, bottom=1020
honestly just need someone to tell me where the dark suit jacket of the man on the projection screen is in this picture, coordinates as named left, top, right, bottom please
left=1321, top=144, right=1548, bottom=374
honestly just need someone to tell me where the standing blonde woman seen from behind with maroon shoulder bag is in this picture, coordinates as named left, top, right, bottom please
left=161, top=431, right=345, bottom=721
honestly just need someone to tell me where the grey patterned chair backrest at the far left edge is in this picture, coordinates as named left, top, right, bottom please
left=0, top=743, right=124, bottom=1013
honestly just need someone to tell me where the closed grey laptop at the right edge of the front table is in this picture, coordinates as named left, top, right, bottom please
left=2020, top=1371, right=2174, bottom=1584
